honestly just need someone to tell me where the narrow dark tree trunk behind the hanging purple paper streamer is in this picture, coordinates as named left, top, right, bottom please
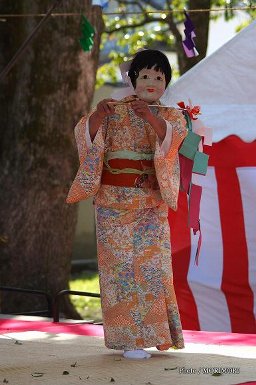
left=167, top=0, right=211, bottom=75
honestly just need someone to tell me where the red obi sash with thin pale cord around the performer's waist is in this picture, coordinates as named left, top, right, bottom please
left=101, top=158, right=155, bottom=187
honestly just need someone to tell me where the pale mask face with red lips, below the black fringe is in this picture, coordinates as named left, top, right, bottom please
left=135, top=67, right=166, bottom=103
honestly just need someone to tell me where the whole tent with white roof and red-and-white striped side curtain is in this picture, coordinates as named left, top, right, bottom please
left=168, top=21, right=256, bottom=333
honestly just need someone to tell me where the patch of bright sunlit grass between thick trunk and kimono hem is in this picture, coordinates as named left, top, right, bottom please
left=69, top=272, right=102, bottom=322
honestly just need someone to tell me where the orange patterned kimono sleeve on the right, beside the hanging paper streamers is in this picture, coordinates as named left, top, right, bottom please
left=154, top=108, right=187, bottom=210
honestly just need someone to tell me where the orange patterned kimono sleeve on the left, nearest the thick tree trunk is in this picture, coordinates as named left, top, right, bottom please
left=66, top=117, right=105, bottom=203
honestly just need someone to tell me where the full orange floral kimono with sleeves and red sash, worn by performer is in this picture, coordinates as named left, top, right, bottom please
left=67, top=96, right=187, bottom=350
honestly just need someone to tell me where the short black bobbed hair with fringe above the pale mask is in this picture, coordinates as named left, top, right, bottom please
left=128, top=49, right=172, bottom=88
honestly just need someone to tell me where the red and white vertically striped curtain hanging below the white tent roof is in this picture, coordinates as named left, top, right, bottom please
left=169, top=136, right=256, bottom=333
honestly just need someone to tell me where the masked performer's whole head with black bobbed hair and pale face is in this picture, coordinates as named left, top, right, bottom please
left=128, top=49, right=172, bottom=102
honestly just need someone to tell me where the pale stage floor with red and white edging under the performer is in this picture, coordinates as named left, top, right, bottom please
left=0, top=317, right=256, bottom=385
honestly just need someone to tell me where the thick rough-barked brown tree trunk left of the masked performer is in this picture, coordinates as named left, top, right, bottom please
left=0, top=0, right=103, bottom=317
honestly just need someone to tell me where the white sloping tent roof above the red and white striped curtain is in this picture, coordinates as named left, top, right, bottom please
left=161, top=21, right=256, bottom=142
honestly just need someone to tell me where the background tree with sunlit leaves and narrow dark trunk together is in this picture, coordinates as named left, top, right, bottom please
left=97, top=0, right=256, bottom=86
